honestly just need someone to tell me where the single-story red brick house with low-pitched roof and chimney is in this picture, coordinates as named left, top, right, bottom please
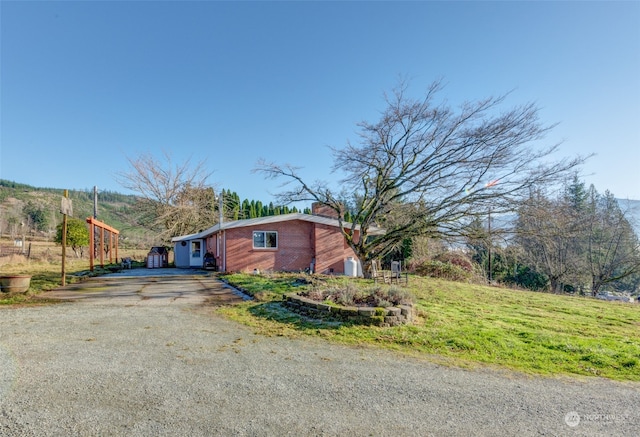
left=171, top=204, right=384, bottom=275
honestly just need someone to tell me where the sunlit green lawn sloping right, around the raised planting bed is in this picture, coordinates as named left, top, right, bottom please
left=219, top=274, right=640, bottom=381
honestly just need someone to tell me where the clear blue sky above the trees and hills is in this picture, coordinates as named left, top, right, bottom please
left=0, top=0, right=640, bottom=201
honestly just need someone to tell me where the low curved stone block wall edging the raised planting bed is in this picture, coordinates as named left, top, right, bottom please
left=283, top=293, right=413, bottom=327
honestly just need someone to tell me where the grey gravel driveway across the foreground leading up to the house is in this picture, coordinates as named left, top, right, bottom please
left=0, top=270, right=640, bottom=436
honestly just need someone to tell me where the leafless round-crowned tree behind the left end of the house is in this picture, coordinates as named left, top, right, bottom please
left=118, top=151, right=217, bottom=241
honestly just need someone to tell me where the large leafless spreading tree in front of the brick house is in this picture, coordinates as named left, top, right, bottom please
left=255, top=78, right=583, bottom=274
